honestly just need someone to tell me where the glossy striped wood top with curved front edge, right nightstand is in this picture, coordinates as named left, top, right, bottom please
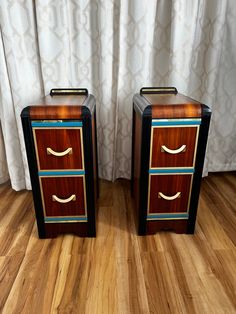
left=143, top=94, right=202, bottom=119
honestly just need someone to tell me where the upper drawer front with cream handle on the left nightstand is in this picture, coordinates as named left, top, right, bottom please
left=33, top=127, right=84, bottom=170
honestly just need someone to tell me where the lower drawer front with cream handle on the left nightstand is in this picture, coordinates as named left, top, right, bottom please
left=40, top=176, right=86, bottom=217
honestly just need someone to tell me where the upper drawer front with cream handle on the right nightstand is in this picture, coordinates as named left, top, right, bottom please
left=150, top=126, right=198, bottom=168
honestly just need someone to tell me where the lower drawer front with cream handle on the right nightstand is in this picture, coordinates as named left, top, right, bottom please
left=148, top=174, right=192, bottom=218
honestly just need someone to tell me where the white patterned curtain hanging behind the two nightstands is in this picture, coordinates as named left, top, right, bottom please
left=0, top=0, right=236, bottom=190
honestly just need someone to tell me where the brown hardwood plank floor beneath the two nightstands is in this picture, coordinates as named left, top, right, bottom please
left=0, top=172, right=236, bottom=314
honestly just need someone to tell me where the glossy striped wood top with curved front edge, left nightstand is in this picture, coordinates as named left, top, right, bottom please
left=30, top=96, right=86, bottom=120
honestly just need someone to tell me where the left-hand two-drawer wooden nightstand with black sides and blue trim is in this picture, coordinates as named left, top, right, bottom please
left=21, top=89, right=98, bottom=238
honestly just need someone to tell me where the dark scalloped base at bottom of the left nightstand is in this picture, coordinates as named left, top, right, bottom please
left=39, top=223, right=96, bottom=239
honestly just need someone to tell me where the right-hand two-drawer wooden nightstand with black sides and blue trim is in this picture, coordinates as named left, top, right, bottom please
left=131, top=87, right=211, bottom=235
